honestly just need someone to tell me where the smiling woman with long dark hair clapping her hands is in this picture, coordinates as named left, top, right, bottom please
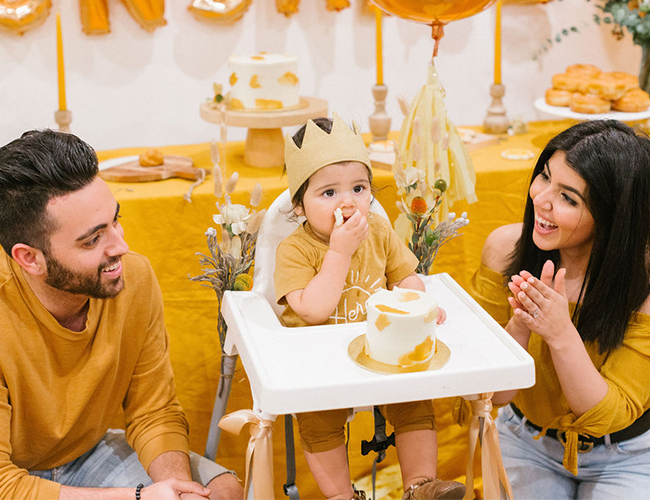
left=472, top=120, right=650, bottom=499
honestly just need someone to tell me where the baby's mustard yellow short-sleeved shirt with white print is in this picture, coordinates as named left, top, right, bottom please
left=273, top=215, right=418, bottom=327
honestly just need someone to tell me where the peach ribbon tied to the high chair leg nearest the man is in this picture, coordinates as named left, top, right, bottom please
left=219, top=410, right=275, bottom=500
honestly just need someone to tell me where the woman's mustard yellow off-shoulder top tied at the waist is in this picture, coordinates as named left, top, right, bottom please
left=469, top=265, right=650, bottom=474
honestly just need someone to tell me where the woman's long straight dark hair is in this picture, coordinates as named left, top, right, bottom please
left=506, top=120, right=650, bottom=353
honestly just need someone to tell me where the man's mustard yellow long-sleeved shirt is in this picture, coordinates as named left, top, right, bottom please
left=0, top=250, right=189, bottom=499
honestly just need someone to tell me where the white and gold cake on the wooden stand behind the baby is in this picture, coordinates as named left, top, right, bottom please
left=228, top=52, right=300, bottom=111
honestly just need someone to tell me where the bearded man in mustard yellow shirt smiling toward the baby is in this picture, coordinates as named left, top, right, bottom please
left=0, top=130, right=243, bottom=500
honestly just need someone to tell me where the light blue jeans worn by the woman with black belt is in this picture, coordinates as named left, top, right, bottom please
left=496, top=405, right=650, bottom=500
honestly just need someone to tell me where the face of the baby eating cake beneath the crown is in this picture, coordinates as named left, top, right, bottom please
left=302, top=161, right=372, bottom=242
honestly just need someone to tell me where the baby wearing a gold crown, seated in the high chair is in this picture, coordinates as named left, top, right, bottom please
left=274, top=114, right=465, bottom=500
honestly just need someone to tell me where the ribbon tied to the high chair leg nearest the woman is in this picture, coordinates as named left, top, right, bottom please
left=465, top=392, right=512, bottom=500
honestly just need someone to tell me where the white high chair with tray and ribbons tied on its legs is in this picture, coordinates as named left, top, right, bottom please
left=211, top=191, right=535, bottom=500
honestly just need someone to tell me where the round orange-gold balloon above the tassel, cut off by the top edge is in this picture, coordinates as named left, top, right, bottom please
left=372, top=0, right=496, bottom=24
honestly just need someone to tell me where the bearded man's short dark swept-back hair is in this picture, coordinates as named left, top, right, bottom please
left=0, top=129, right=98, bottom=255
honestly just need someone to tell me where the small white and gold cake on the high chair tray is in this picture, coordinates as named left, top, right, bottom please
left=365, top=287, right=438, bottom=367
